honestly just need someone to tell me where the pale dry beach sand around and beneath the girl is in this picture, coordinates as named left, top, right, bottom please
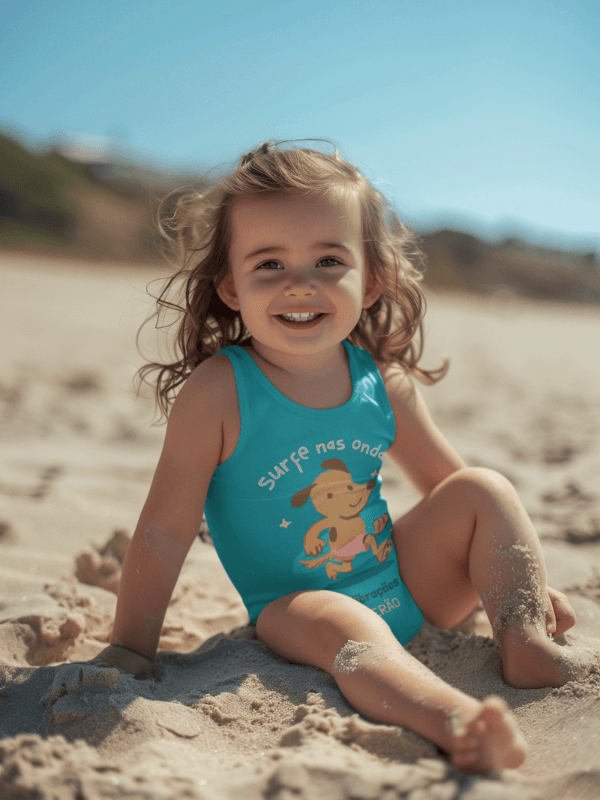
left=0, top=255, right=600, bottom=800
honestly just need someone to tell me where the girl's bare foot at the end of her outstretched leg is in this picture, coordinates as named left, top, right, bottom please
left=450, top=697, right=527, bottom=772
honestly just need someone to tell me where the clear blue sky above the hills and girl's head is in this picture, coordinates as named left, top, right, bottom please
left=0, top=0, right=600, bottom=250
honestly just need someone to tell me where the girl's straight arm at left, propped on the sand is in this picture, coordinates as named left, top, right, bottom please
left=94, top=357, right=236, bottom=674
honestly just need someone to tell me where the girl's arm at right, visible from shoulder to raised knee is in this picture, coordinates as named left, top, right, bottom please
left=378, top=364, right=466, bottom=496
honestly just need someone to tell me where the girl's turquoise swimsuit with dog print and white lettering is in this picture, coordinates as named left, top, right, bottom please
left=205, top=342, right=423, bottom=644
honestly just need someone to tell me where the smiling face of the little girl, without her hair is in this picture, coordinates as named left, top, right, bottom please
left=217, top=193, right=380, bottom=360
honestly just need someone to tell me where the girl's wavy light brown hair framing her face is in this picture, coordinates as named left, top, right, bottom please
left=138, top=140, right=448, bottom=417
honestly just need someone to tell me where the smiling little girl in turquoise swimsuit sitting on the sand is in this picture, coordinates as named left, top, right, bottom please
left=95, top=142, right=575, bottom=771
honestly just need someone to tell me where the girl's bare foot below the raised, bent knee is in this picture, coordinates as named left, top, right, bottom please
left=498, top=624, right=592, bottom=689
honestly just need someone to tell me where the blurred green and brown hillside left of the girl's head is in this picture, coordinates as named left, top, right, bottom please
left=0, top=135, right=198, bottom=263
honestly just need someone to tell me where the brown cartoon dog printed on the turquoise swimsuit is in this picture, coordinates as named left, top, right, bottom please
left=292, top=458, right=392, bottom=580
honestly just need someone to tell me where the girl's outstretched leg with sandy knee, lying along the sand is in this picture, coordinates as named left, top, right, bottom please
left=256, top=591, right=526, bottom=771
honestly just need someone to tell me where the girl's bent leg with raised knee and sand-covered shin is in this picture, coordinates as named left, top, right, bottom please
left=392, top=469, right=578, bottom=688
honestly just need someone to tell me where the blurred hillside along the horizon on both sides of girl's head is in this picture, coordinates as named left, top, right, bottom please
left=0, top=135, right=600, bottom=302
